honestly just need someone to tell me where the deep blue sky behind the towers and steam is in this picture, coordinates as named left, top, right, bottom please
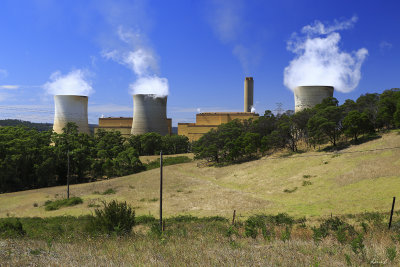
left=0, top=0, right=400, bottom=125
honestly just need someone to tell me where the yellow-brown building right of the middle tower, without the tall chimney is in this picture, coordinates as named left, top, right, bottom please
left=178, top=112, right=259, bottom=142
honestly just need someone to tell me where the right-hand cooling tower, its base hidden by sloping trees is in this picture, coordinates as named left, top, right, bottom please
left=294, top=86, right=333, bottom=112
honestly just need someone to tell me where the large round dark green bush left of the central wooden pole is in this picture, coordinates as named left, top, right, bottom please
left=91, top=200, right=135, bottom=235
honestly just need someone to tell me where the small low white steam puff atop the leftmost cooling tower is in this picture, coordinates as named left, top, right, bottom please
left=43, top=69, right=93, bottom=96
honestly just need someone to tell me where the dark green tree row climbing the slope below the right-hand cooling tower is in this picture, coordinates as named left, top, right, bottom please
left=192, top=88, right=400, bottom=163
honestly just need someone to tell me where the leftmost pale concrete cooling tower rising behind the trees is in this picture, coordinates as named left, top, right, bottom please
left=53, top=95, right=90, bottom=134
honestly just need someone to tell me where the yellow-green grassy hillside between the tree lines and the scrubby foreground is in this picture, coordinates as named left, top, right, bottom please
left=0, top=131, right=400, bottom=220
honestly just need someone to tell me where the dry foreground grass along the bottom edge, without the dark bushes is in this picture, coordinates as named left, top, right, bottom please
left=0, top=213, right=400, bottom=266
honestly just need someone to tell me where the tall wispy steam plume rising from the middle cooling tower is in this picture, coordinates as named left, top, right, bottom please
left=103, top=27, right=169, bottom=97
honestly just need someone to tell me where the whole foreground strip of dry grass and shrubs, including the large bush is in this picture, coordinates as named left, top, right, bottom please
left=0, top=201, right=400, bottom=266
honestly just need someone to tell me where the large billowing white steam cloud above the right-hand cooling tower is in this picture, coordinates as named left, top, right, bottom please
left=284, top=16, right=368, bottom=93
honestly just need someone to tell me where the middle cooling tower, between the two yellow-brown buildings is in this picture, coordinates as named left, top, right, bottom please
left=131, top=94, right=168, bottom=135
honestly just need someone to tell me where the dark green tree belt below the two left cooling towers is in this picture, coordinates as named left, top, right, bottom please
left=0, top=123, right=190, bottom=193
